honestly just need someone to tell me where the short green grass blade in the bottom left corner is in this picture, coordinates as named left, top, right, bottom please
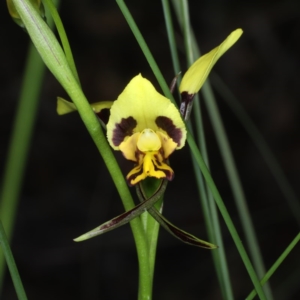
left=0, top=221, right=27, bottom=300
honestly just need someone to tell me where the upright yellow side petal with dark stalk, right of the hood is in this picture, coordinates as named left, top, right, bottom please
left=179, top=29, right=243, bottom=120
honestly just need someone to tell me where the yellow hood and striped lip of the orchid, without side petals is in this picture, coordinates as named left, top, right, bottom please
left=107, top=75, right=186, bottom=185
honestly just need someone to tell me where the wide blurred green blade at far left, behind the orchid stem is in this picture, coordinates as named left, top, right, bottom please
left=0, top=1, right=59, bottom=291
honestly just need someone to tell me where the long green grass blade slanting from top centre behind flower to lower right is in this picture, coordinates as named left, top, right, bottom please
left=116, top=0, right=266, bottom=300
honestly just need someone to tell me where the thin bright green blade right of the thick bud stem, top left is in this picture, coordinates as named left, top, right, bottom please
left=44, top=0, right=80, bottom=85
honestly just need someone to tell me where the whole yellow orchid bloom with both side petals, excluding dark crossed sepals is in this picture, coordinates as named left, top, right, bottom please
left=57, top=29, right=243, bottom=185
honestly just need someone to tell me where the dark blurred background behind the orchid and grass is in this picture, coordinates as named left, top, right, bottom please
left=0, top=0, right=300, bottom=300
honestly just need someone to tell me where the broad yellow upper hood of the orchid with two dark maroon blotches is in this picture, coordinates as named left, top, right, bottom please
left=107, top=74, right=186, bottom=150
